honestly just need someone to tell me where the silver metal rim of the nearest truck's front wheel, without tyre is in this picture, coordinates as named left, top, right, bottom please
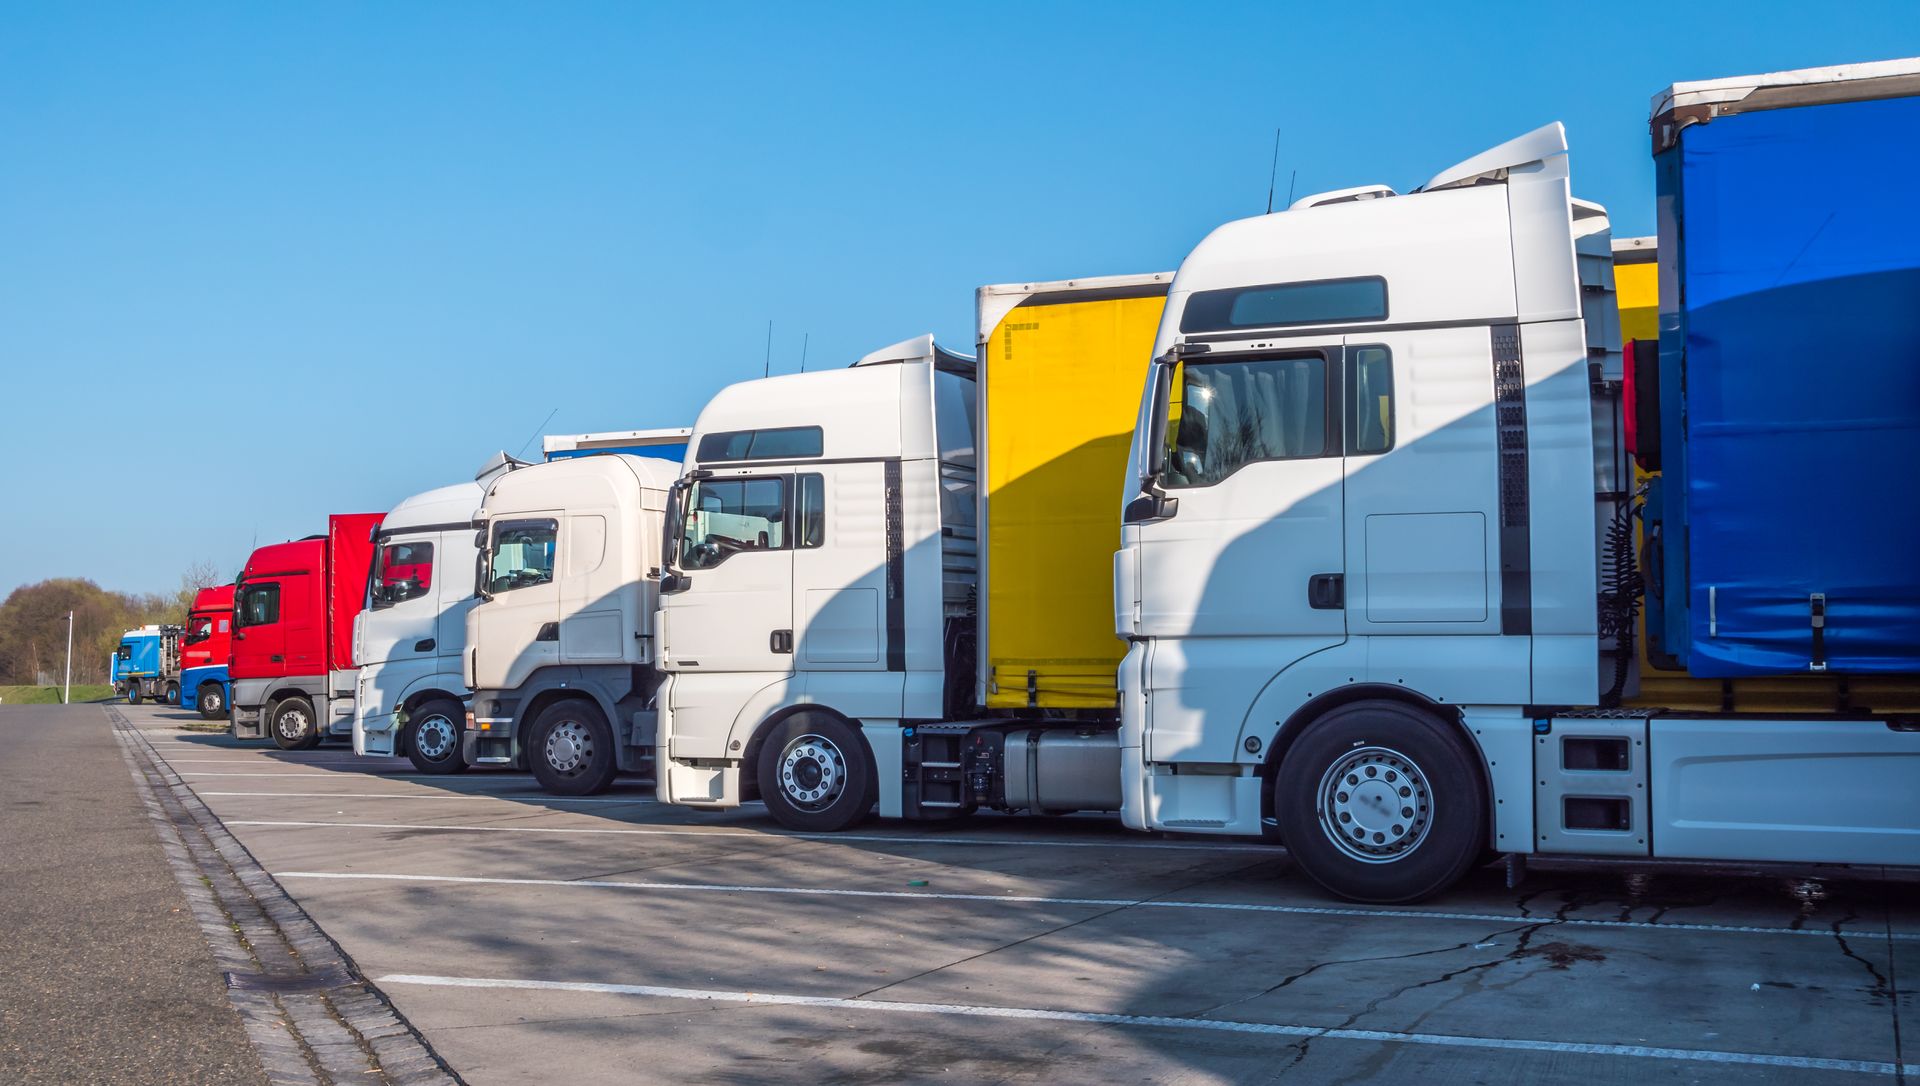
left=1319, top=746, right=1434, bottom=863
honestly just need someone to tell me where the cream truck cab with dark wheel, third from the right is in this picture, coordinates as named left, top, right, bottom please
left=461, top=447, right=684, bottom=794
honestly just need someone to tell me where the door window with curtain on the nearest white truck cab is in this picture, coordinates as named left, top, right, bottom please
left=1164, top=353, right=1338, bottom=487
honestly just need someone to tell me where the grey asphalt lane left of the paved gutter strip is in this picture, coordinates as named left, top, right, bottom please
left=0, top=704, right=267, bottom=1084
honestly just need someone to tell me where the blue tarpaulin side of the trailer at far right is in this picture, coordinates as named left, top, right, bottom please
left=1659, top=89, right=1920, bottom=677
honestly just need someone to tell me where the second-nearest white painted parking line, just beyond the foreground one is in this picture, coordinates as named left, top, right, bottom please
left=273, top=871, right=1920, bottom=940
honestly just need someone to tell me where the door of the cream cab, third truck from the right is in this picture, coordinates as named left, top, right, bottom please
left=472, top=510, right=561, bottom=689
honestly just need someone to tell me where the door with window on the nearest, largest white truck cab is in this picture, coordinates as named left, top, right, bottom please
left=1139, top=336, right=1346, bottom=758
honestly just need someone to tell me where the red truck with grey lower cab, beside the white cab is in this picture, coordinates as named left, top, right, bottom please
left=230, top=512, right=382, bottom=750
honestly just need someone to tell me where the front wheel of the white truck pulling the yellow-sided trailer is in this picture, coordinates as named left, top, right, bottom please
left=758, top=714, right=876, bottom=833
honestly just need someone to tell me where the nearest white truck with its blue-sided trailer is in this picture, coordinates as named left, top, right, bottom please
left=1116, top=61, right=1920, bottom=902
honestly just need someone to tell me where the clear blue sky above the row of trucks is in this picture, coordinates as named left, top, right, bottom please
left=0, top=0, right=1920, bottom=593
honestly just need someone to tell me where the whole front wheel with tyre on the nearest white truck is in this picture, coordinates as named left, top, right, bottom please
left=1273, top=700, right=1486, bottom=906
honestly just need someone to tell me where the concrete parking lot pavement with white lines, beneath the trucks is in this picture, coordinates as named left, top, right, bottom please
left=112, top=710, right=1920, bottom=1084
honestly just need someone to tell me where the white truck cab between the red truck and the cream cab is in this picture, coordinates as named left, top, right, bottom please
left=353, top=453, right=526, bottom=773
